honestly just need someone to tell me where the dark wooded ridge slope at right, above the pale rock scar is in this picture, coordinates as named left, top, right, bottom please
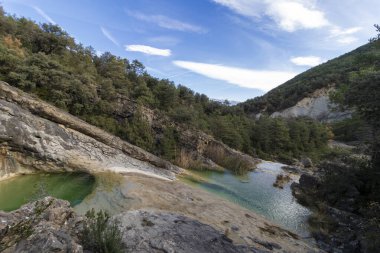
left=239, top=43, right=380, bottom=114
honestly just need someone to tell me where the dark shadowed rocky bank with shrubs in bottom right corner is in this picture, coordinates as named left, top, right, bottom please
left=291, top=174, right=380, bottom=253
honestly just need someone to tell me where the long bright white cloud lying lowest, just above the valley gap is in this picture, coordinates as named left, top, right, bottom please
left=173, top=61, right=297, bottom=91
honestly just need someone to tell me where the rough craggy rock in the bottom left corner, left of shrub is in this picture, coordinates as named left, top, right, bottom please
left=0, top=197, right=83, bottom=253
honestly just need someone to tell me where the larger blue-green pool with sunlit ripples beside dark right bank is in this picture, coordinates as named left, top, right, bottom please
left=184, top=162, right=310, bottom=236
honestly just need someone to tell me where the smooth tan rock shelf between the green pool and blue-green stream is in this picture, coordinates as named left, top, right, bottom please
left=75, top=174, right=318, bottom=252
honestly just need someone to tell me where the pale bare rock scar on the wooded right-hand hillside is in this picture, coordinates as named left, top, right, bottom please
left=271, top=88, right=351, bottom=122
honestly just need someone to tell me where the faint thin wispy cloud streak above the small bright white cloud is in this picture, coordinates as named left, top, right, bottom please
left=127, top=11, right=206, bottom=33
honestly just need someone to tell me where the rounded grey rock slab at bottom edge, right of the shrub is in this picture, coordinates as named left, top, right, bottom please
left=116, top=210, right=260, bottom=253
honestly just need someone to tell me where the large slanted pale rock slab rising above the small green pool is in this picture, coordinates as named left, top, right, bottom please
left=0, top=82, right=181, bottom=179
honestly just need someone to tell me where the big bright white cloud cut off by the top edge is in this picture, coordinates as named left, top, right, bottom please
left=213, top=0, right=329, bottom=32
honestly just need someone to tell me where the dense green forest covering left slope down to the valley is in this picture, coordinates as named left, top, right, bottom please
left=0, top=6, right=331, bottom=166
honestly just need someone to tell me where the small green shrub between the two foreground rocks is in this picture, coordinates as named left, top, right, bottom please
left=81, top=209, right=123, bottom=253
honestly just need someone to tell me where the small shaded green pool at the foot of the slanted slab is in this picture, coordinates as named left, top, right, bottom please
left=0, top=173, right=95, bottom=211
